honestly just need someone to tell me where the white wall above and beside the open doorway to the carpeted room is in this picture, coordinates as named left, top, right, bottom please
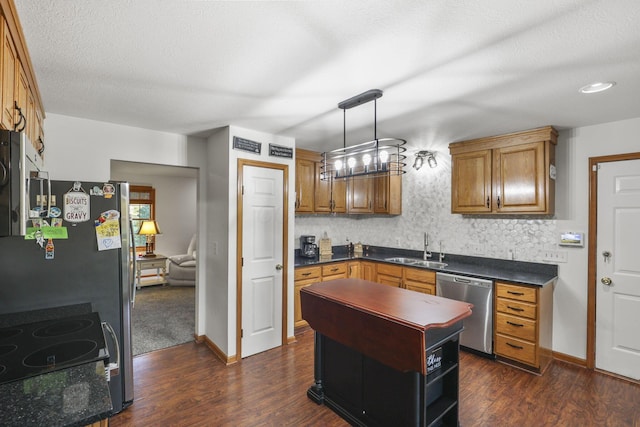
left=44, top=113, right=207, bottom=334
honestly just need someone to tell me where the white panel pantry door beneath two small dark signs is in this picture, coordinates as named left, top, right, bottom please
left=241, top=165, right=284, bottom=357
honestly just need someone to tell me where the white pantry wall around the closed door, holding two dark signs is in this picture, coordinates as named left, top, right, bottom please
left=207, top=126, right=295, bottom=357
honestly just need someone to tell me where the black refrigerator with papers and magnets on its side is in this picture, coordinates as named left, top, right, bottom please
left=0, top=181, right=135, bottom=413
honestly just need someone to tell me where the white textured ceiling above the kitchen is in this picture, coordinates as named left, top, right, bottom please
left=14, top=0, right=640, bottom=150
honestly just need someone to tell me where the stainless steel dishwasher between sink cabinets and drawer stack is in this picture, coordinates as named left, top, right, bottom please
left=436, top=273, right=493, bottom=357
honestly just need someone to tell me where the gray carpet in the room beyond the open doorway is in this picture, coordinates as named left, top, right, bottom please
left=131, top=286, right=195, bottom=356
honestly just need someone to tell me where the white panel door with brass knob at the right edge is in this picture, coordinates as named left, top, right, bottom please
left=596, top=160, right=640, bottom=380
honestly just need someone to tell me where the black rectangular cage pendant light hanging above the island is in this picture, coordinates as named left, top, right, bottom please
left=321, top=89, right=407, bottom=181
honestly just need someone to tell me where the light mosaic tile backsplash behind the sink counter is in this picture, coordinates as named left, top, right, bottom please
left=295, top=162, right=557, bottom=262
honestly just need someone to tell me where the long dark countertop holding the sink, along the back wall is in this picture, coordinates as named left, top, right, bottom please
left=295, top=246, right=558, bottom=286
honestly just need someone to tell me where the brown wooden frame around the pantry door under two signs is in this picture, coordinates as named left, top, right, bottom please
left=236, top=159, right=289, bottom=360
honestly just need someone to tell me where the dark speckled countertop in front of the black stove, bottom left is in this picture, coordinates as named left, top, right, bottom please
left=0, top=361, right=113, bottom=427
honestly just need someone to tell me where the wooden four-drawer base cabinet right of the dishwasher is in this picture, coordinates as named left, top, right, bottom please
left=494, top=282, right=553, bottom=373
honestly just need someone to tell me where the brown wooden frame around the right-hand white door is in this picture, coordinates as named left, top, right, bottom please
left=587, top=152, right=640, bottom=369
